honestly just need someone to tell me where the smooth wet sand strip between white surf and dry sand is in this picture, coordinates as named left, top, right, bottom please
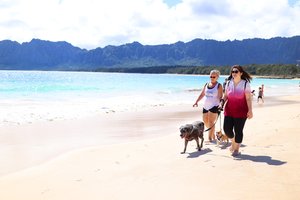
left=0, top=105, right=201, bottom=177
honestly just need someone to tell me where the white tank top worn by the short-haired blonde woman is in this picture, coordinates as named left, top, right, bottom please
left=203, top=82, right=220, bottom=110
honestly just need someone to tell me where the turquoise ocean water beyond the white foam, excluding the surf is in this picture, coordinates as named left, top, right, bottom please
left=0, top=71, right=299, bottom=98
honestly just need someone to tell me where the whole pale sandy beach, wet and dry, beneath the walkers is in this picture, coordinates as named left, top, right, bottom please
left=0, top=95, right=300, bottom=200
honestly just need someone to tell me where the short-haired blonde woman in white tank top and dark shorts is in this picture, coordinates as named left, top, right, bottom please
left=193, top=70, right=223, bottom=142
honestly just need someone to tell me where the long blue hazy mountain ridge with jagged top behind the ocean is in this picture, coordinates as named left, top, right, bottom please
left=0, top=36, right=300, bottom=70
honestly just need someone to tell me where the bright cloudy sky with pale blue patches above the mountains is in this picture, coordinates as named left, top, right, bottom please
left=0, top=0, right=300, bottom=49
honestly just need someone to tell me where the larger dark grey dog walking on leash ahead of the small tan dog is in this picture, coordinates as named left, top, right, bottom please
left=179, top=121, right=204, bottom=153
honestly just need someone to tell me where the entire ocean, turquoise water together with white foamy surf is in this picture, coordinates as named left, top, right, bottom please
left=0, top=70, right=300, bottom=125
